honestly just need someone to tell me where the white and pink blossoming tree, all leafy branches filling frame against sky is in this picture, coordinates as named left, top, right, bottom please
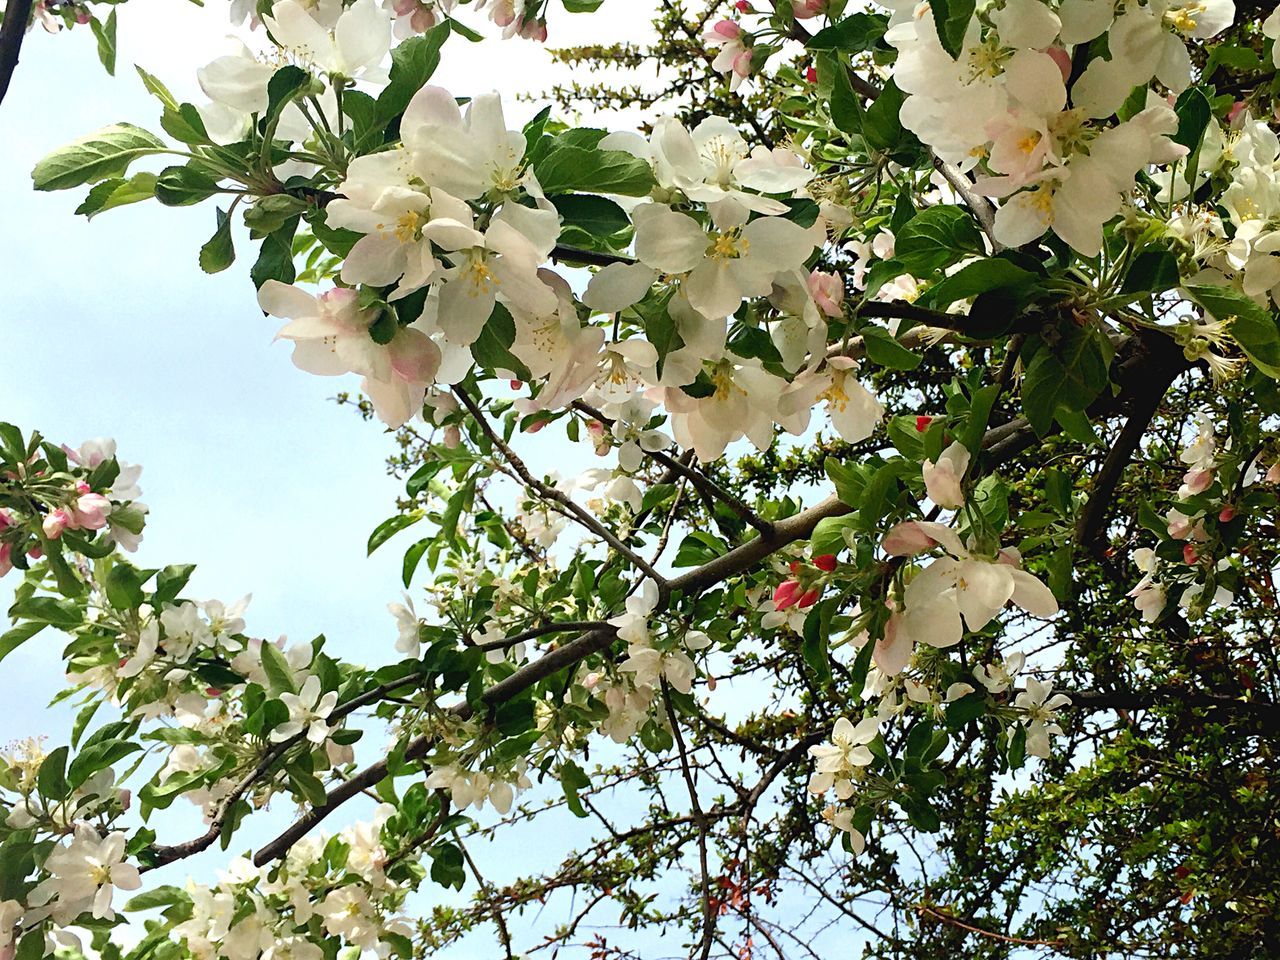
left=0, top=0, right=1280, bottom=960
